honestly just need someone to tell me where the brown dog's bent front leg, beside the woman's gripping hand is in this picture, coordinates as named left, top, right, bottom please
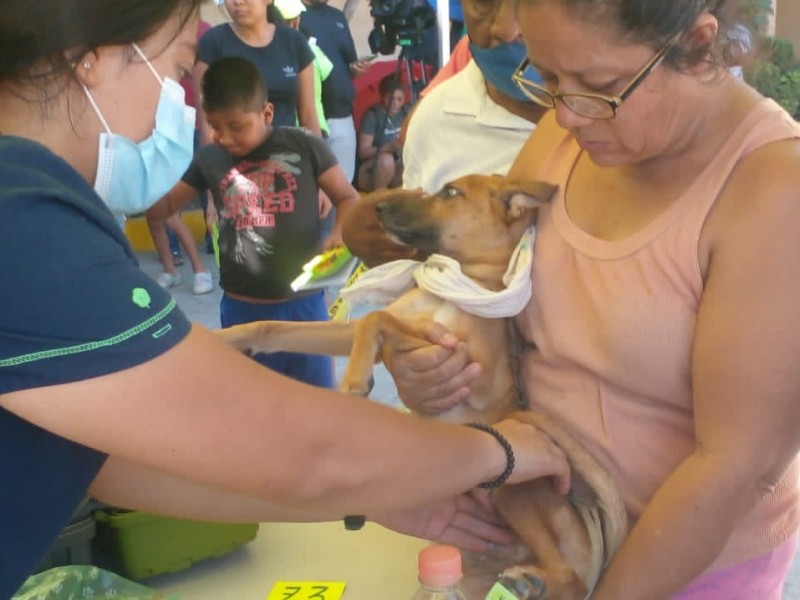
left=339, top=310, right=430, bottom=396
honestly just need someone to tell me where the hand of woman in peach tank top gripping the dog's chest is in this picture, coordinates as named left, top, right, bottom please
left=386, top=322, right=482, bottom=415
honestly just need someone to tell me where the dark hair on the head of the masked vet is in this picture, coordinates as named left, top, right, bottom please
left=0, top=0, right=203, bottom=85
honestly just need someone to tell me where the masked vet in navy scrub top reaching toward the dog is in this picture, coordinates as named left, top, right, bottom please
left=0, top=0, right=569, bottom=598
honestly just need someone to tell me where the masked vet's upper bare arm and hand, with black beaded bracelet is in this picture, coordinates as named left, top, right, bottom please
left=0, top=326, right=568, bottom=520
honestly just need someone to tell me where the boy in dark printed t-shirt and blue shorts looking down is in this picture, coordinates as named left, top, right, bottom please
left=148, top=57, right=358, bottom=387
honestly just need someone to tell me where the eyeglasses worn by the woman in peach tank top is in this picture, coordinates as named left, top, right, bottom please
left=511, top=35, right=678, bottom=119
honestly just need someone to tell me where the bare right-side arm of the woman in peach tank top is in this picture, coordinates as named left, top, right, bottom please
left=592, top=142, right=800, bottom=600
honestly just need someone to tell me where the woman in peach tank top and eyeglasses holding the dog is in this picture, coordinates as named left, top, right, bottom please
left=373, top=0, right=800, bottom=600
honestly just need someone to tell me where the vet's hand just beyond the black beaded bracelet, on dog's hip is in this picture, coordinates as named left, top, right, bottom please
left=493, top=418, right=571, bottom=494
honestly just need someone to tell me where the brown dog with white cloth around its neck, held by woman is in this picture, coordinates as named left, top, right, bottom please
left=219, top=175, right=627, bottom=600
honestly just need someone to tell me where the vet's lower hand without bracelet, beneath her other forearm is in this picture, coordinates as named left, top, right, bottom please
left=370, top=495, right=517, bottom=552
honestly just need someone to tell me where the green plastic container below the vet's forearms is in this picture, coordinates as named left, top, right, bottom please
left=94, top=511, right=258, bottom=579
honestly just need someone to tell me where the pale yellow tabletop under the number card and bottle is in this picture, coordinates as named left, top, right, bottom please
left=142, top=522, right=429, bottom=600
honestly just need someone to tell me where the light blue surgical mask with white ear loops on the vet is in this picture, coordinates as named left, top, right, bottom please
left=83, top=44, right=195, bottom=215
